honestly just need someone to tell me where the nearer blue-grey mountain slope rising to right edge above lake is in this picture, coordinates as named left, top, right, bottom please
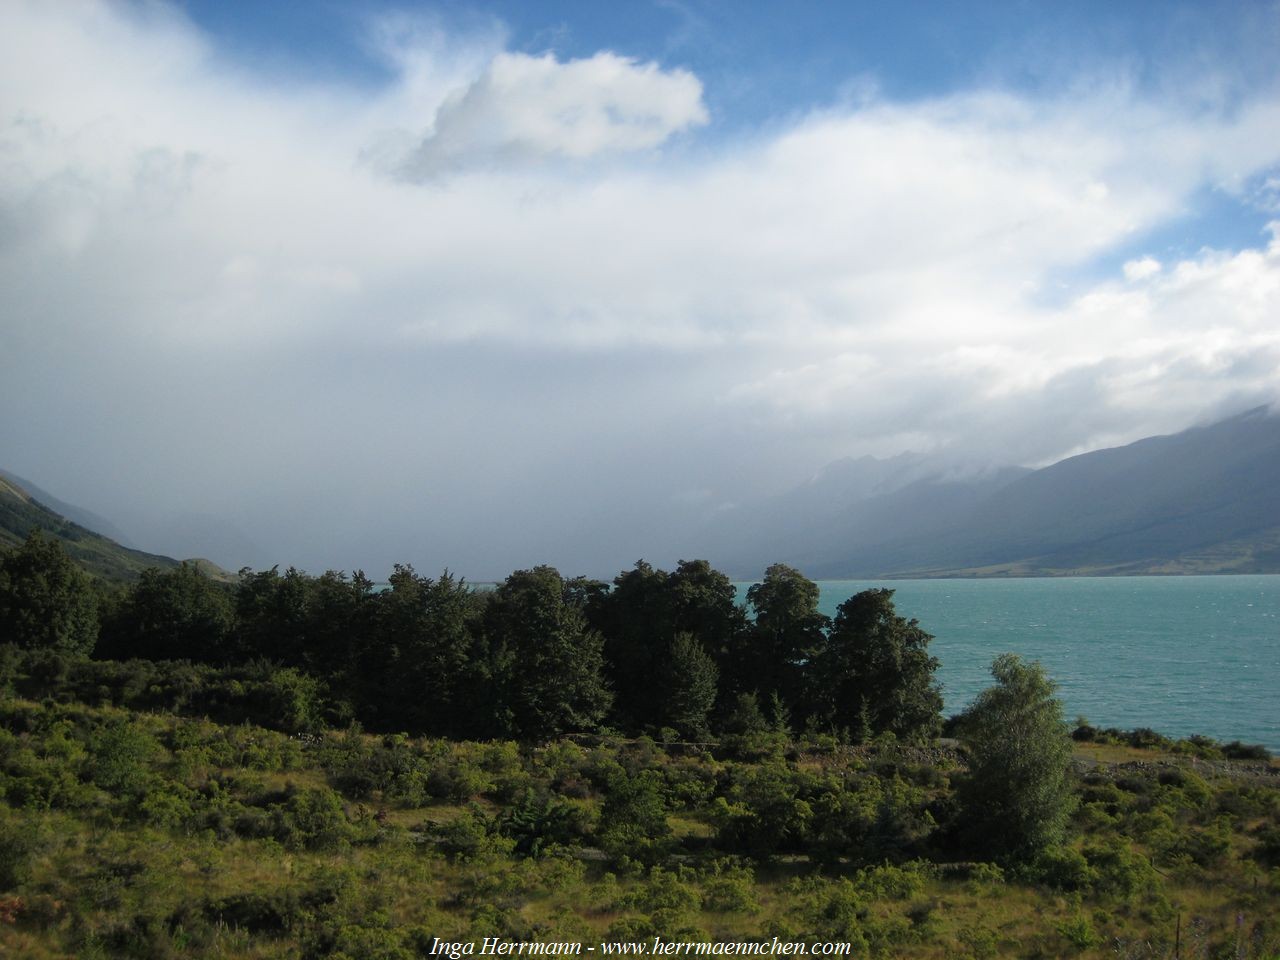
left=814, top=408, right=1280, bottom=576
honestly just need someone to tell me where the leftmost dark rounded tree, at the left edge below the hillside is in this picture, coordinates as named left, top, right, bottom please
left=0, top=530, right=99, bottom=654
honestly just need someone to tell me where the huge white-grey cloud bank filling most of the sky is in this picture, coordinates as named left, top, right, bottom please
left=0, top=4, right=1280, bottom=570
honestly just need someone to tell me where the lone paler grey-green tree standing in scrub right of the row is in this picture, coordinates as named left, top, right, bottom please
left=957, top=653, right=1074, bottom=860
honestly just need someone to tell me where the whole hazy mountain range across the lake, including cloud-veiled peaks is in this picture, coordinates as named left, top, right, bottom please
left=708, top=407, right=1280, bottom=579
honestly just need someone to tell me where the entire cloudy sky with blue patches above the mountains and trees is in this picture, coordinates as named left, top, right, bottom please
left=0, top=0, right=1280, bottom=580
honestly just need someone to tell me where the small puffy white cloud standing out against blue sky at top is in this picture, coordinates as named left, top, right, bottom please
left=402, top=51, right=708, bottom=179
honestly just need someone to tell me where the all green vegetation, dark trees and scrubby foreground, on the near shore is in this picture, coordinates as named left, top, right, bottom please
left=0, top=540, right=1280, bottom=960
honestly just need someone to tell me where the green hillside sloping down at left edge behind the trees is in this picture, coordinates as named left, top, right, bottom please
left=0, top=474, right=230, bottom=582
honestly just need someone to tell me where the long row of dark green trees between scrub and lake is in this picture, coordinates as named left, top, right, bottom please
left=0, top=536, right=942, bottom=742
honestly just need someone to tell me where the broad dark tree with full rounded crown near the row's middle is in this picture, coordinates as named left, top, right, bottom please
left=484, top=566, right=612, bottom=741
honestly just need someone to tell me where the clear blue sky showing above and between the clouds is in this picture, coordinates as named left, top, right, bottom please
left=182, top=0, right=1280, bottom=285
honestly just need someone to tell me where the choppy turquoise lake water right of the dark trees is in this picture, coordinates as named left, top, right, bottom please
left=798, top=576, right=1280, bottom=751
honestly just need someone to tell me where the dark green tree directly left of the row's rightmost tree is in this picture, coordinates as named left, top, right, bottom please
left=745, top=563, right=831, bottom=717
